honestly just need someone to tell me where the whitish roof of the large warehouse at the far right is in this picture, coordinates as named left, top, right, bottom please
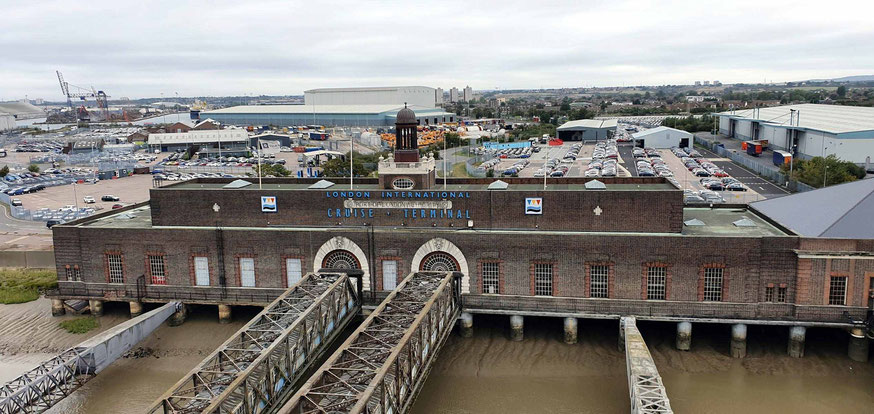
left=717, top=104, right=874, bottom=134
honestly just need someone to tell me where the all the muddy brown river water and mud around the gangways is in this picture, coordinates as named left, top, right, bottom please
left=0, top=299, right=874, bottom=414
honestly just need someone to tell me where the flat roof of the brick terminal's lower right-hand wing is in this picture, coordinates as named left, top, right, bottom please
left=683, top=207, right=789, bottom=237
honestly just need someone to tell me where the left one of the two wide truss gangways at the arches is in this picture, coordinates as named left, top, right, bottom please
left=148, top=269, right=362, bottom=413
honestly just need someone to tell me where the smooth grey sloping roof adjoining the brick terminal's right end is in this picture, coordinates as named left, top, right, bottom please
left=750, top=179, right=874, bottom=239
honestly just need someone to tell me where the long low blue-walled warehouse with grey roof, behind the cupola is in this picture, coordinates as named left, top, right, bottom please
left=201, top=104, right=458, bottom=127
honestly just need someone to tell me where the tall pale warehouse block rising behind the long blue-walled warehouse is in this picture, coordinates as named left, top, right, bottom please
left=303, top=86, right=437, bottom=108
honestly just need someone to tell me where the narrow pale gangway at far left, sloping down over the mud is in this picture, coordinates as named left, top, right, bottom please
left=0, top=302, right=182, bottom=414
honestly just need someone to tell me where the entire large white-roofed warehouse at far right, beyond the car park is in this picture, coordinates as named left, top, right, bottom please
left=714, top=104, right=874, bottom=165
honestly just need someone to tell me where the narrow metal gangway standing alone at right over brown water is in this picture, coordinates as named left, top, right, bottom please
left=619, top=316, right=674, bottom=414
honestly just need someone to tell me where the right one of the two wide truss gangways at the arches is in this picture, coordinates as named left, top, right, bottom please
left=279, top=272, right=461, bottom=414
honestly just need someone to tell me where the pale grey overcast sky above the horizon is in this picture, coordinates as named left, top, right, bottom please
left=0, top=0, right=874, bottom=100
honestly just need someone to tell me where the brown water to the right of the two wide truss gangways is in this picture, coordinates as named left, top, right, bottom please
left=412, top=317, right=874, bottom=414
